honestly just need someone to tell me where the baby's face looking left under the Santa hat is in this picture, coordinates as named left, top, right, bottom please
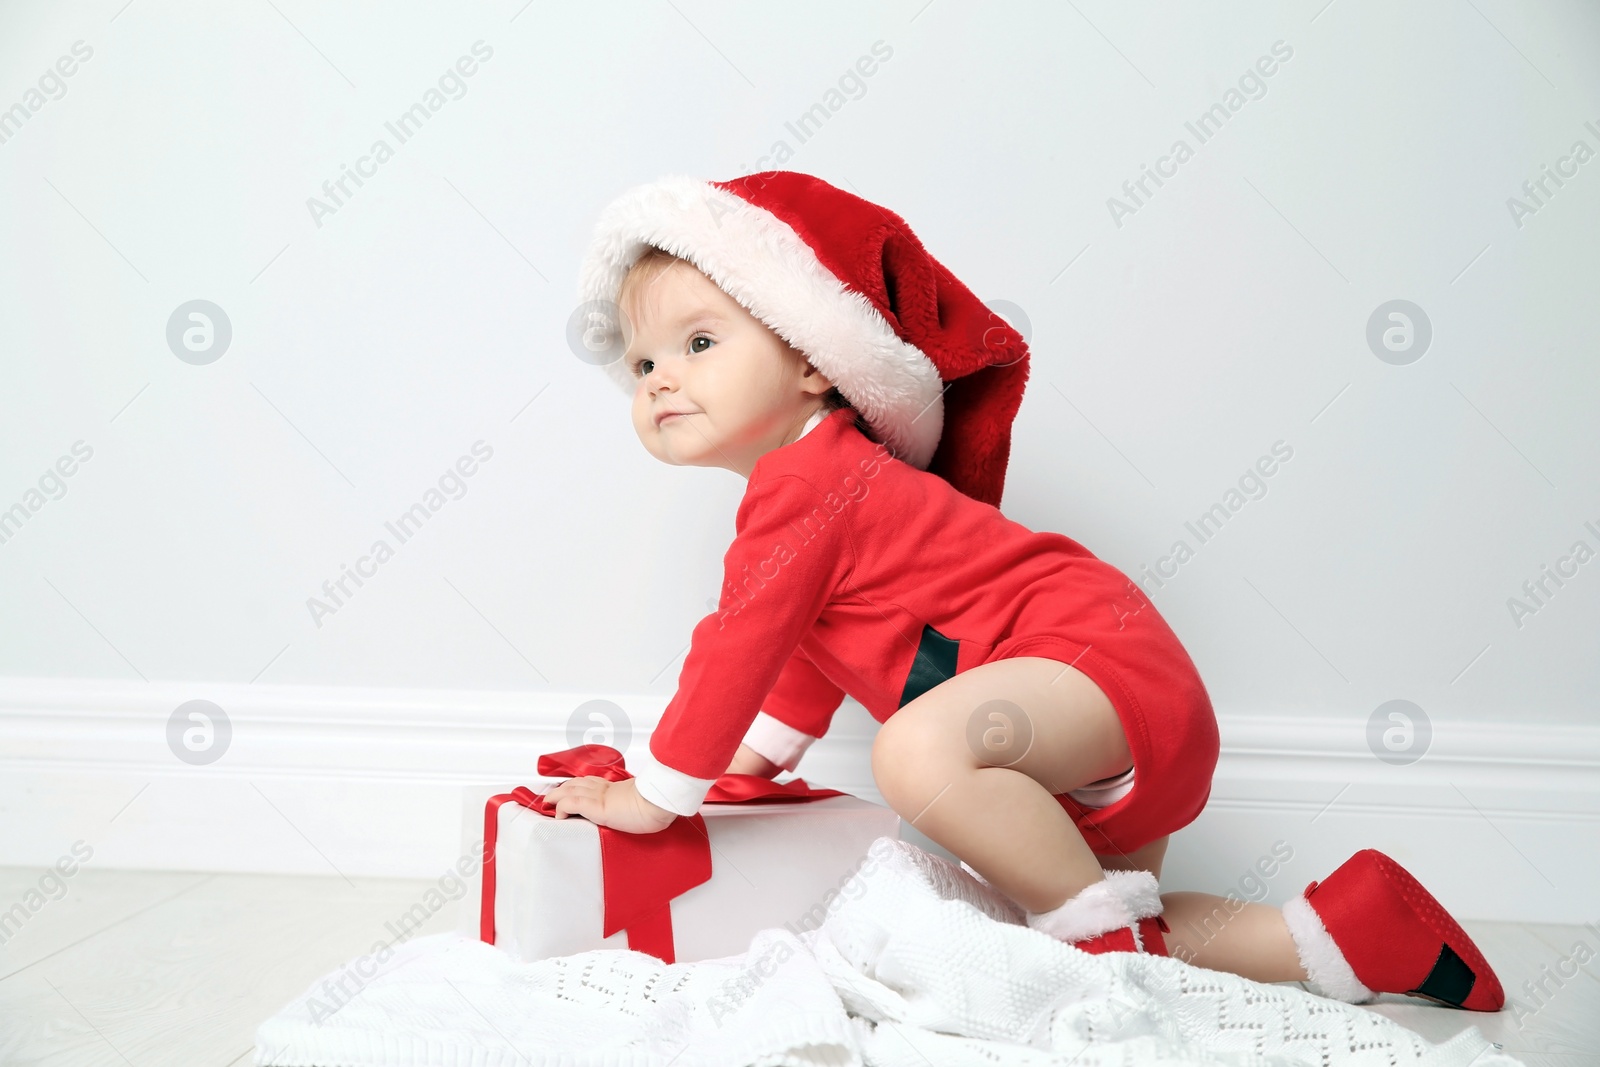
left=621, top=262, right=832, bottom=478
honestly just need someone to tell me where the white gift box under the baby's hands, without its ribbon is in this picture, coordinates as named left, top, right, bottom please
left=459, top=781, right=899, bottom=963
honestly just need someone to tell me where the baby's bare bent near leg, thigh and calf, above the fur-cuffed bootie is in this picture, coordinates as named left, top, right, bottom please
left=872, top=656, right=1133, bottom=912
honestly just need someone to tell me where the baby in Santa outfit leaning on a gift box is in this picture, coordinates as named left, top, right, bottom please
left=546, top=171, right=1504, bottom=1011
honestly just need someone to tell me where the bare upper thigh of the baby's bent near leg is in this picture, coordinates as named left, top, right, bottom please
left=872, top=656, right=1133, bottom=793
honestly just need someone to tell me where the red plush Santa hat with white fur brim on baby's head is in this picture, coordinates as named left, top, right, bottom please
left=579, top=171, right=1027, bottom=507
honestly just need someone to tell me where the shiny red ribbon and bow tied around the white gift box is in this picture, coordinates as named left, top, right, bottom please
left=478, top=745, right=845, bottom=963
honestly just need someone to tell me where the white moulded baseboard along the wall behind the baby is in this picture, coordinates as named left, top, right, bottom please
left=0, top=678, right=1600, bottom=923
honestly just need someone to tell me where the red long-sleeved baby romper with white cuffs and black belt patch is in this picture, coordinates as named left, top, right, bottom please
left=629, top=408, right=1218, bottom=854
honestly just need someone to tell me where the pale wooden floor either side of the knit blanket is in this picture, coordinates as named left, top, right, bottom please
left=0, top=867, right=1600, bottom=1067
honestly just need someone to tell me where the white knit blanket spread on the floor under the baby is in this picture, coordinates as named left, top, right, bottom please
left=254, top=837, right=1518, bottom=1067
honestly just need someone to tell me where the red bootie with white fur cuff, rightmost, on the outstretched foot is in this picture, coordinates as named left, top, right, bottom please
left=1283, top=848, right=1506, bottom=1011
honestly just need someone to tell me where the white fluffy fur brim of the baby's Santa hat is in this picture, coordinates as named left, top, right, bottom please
left=579, top=176, right=944, bottom=470
